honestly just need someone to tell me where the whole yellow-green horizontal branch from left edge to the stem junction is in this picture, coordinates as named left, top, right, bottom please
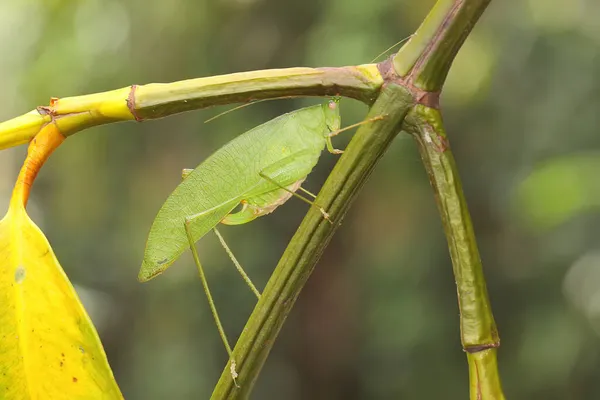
left=0, top=64, right=383, bottom=150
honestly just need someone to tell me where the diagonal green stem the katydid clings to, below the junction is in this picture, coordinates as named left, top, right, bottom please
left=211, top=83, right=412, bottom=399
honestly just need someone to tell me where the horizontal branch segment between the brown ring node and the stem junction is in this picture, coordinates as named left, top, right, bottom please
left=135, top=64, right=383, bottom=119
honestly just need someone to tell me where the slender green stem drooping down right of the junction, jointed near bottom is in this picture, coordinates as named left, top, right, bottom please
left=404, top=105, right=504, bottom=400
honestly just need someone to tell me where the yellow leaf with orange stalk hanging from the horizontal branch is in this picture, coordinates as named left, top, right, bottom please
left=0, top=123, right=122, bottom=400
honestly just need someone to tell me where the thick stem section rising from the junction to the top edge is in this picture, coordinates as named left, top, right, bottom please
left=393, top=0, right=491, bottom=92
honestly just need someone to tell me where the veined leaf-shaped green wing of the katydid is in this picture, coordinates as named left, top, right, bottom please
left=138, top=105, right=328, bottom=281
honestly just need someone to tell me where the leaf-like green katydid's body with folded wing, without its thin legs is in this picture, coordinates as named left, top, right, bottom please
left=138, top=100, right=340, bottom=281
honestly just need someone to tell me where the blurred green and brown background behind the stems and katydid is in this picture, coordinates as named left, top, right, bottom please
left=0, top=0, right=600, bottom=400
